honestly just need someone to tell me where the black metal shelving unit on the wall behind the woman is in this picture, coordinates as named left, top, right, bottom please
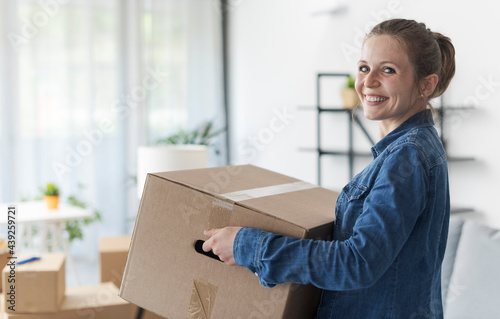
left=299, top=73, right=475, bottom=213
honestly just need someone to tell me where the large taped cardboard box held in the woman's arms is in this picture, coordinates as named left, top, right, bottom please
left=120, top=165, right=338, bottom=319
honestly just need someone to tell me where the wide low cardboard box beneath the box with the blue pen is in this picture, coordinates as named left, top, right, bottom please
left=4, top=282, right=131, bottom=319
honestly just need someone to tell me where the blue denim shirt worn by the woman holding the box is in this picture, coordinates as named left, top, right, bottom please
left=233, top=110, right=450, bottom=319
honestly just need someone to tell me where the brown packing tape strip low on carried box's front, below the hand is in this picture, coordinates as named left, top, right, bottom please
left=187, top=279, right=217, bottom=319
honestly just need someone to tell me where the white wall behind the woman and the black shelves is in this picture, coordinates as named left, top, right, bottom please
left=230, top=0, right=500, bottom=229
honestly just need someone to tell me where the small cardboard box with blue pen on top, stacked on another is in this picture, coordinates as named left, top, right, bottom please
left=2, top=253, right=66, bottom=313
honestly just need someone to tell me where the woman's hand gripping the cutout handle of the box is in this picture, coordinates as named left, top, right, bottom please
left=203, top=227, right=241, bottom=266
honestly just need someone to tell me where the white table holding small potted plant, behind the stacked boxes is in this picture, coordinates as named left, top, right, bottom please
left=0, top=201, right=93, bottom=284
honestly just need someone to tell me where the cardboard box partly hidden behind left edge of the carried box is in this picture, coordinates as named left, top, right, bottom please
left=99, top=236, right=161, bottom=319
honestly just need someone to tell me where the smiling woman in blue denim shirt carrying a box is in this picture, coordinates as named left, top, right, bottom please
left=204, top=19, right=455, bottom=318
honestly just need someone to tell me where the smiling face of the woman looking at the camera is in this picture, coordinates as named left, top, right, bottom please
left=356, top=35, right=426, bottom=133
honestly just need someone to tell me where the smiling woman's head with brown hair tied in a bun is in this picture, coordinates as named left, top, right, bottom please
left=356, top=19, right=455, bottom=137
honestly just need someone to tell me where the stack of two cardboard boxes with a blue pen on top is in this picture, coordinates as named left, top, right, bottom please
left=0, top=253, right=131, bottom=319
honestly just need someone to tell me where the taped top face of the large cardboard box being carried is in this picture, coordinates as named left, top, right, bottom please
left=152, top=165, right=338, bottom=230
